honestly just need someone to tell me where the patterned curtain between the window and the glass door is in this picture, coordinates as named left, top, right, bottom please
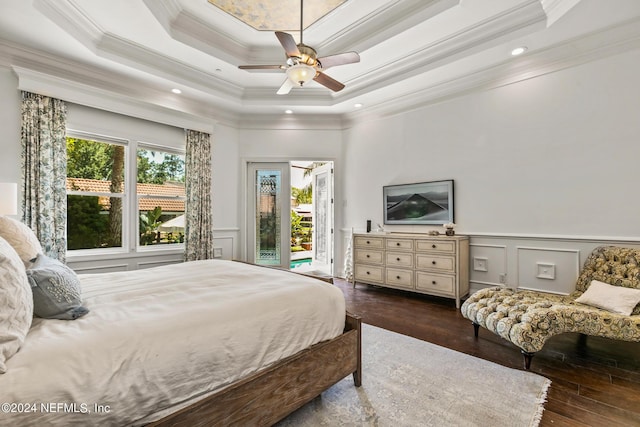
left=184, top=130, right=213, bottom=261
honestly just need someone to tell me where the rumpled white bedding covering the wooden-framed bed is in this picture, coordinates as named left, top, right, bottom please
left=0, top=260, right=345, bottom=426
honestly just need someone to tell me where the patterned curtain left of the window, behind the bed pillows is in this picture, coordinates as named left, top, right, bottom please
left=21, top=92, right=67, bottom=262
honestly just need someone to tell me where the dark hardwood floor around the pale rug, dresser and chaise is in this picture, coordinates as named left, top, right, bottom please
left=335, top=279, right=640, bottom=427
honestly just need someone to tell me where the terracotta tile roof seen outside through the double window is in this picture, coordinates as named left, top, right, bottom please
left=67, top=178, right=185, bottom=212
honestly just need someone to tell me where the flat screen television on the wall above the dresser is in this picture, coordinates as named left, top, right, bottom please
left=382, top=179, right=454, bottom=225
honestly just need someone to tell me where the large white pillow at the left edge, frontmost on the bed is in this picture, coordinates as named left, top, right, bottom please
left=0, top=237, right=33, bottom=374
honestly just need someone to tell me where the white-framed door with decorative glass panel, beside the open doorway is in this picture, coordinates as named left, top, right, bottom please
left=247, top=162, right=291, bottom=269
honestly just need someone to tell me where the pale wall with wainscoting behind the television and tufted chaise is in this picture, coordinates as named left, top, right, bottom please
left=342, top=47, right=640, bottom=292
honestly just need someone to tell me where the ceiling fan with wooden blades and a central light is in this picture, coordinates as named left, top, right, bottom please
left=238, top=0, right=360, bottom=95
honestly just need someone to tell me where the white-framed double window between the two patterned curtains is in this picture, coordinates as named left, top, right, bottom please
left=67, top=134, right=185, bottom=251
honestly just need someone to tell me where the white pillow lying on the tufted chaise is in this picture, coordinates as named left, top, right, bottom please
left=576, top=280, right=640, bottom=316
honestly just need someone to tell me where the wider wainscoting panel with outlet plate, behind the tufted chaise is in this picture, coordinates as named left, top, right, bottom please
left=516, top=246, right=581, bottom=294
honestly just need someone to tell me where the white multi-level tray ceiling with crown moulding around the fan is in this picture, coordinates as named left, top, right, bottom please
left=0, top=0, right=640, bottom=120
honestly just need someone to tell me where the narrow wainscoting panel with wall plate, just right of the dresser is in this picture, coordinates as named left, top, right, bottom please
left=469, top=243, right=507, bottom=289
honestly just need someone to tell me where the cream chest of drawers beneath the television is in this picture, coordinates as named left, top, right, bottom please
left=353, top=233, right=469, bottom=308
